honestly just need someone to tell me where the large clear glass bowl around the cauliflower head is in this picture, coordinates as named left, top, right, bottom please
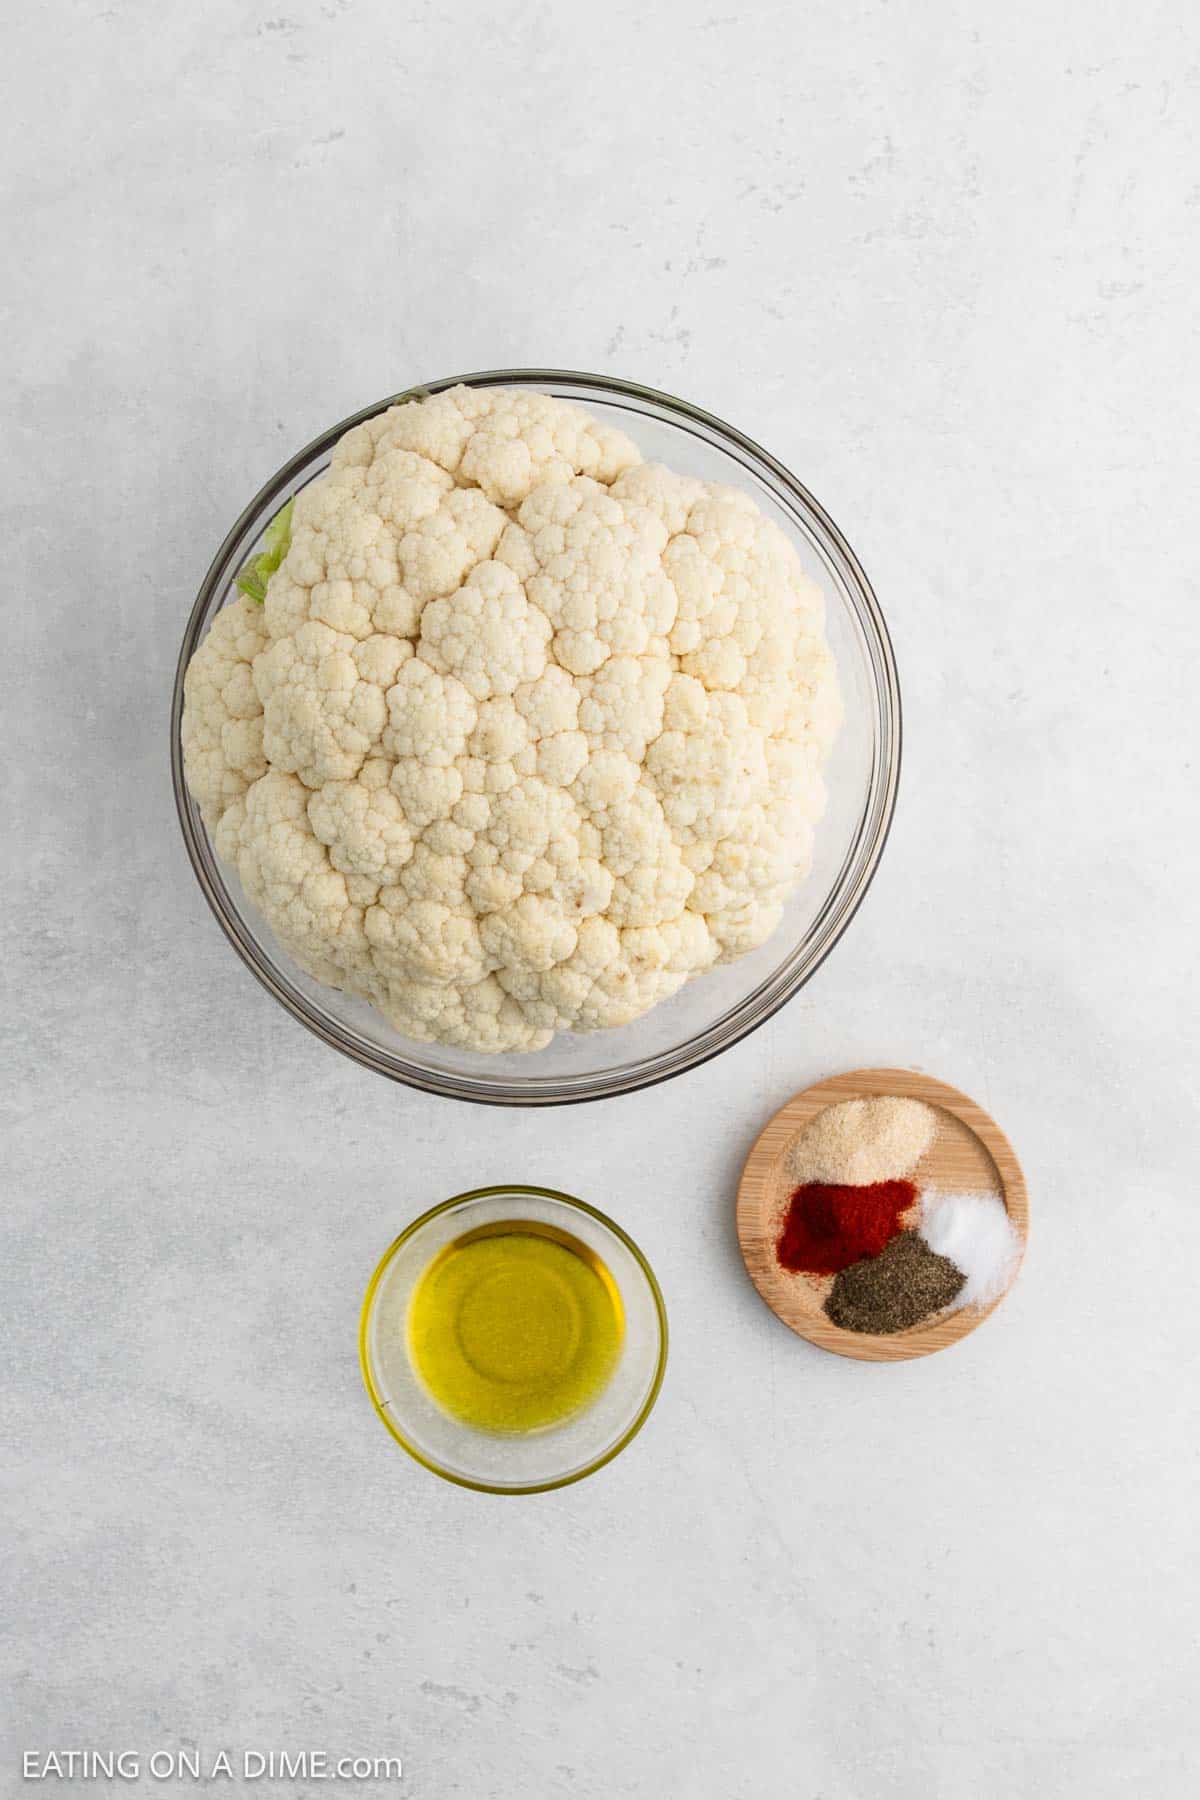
left=171, top=369, right=900, bottom=1105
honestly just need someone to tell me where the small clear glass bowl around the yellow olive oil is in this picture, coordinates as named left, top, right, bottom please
left=358, top=1188, right=667, bottom=1494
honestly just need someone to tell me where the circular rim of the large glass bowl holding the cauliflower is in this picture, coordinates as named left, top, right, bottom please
left=171, top=369, right=903, bottom=1107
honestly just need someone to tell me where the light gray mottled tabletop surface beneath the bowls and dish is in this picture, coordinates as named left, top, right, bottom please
left=0, top=0, right=1200, bottom=1800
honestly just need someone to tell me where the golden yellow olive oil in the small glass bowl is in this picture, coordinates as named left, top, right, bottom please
left=408, top=1219, right=624, bottom=1433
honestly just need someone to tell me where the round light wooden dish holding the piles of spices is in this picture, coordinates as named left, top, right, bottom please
left=738, top=1069, right=1029, bottom=1363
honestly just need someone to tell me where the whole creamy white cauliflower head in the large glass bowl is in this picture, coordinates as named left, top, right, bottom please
left=182, top=387, right=840, bottom=1051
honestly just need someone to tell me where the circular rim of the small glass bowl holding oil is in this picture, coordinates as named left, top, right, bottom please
left=358, top=1183, right=669, bottom=1494
